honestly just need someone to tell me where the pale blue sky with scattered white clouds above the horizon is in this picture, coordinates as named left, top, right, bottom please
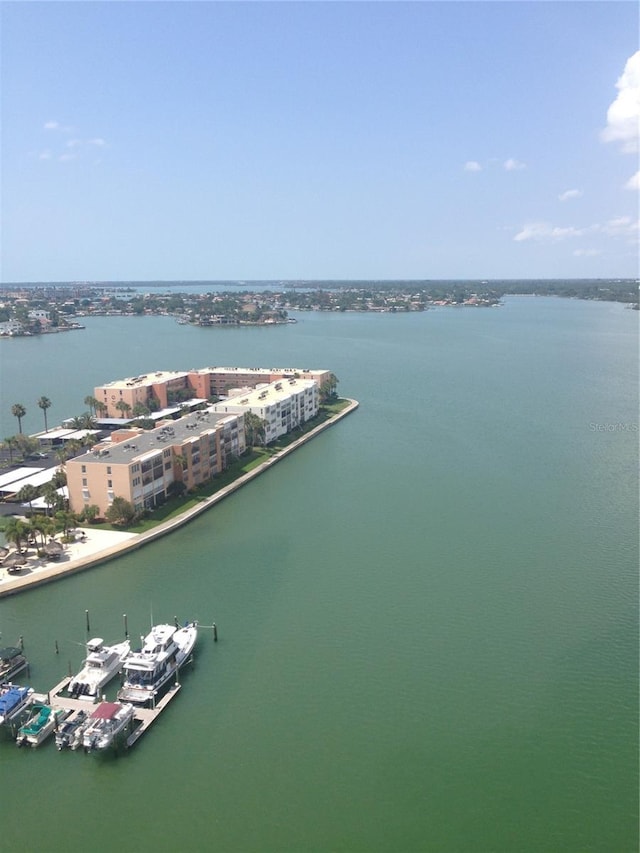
left=0, top=0, right=640, bottom=283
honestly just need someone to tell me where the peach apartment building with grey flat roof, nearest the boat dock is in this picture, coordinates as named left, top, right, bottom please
left=66, top=410, right=245, bottom=517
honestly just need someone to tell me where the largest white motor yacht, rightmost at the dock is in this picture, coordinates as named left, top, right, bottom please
left=118, top=622, right=198, bottom=705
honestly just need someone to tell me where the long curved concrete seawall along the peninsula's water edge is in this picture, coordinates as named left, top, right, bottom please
left=0, top=398, right=359, bottom=598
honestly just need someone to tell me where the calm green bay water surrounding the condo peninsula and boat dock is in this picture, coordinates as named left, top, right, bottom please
left=0, top=298, right=638, bottom=853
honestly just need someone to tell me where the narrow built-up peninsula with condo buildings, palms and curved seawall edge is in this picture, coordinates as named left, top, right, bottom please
left=0, top=368, right=358, bottom=597
